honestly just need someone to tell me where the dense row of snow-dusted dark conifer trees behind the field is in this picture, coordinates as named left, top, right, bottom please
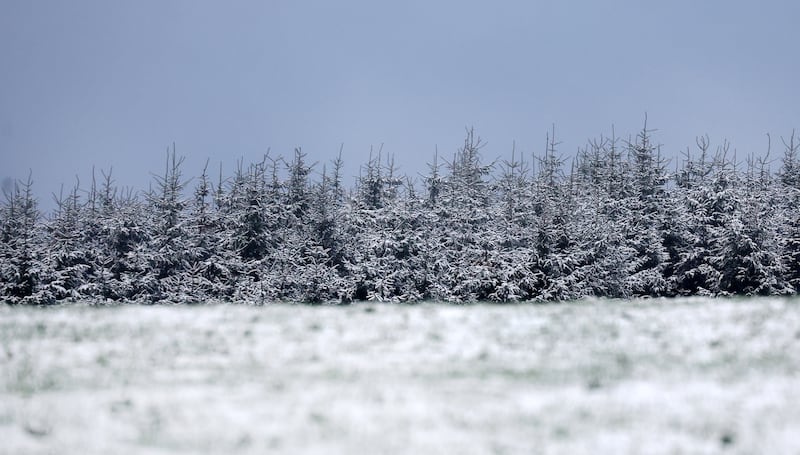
left=0, top=126, right=800, bottom=304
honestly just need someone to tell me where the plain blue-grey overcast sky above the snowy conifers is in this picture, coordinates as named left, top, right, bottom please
left=0, top=0, right=800, bottom=208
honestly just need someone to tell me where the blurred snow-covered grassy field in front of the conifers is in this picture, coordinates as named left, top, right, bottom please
left=0, top=299, right=800, bottom=454
